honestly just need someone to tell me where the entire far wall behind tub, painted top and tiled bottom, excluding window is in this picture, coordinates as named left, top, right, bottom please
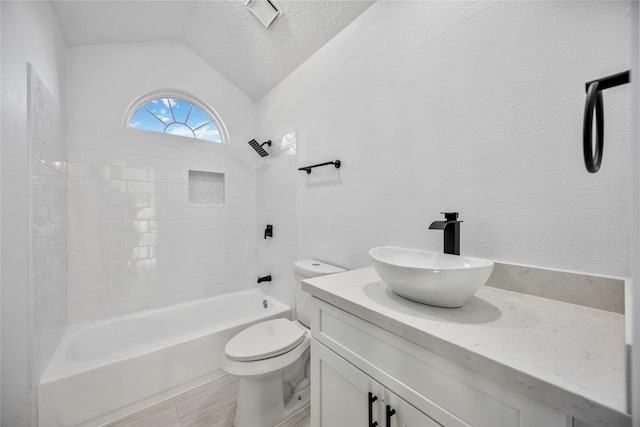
left=68, top=42, right=258, bottom=323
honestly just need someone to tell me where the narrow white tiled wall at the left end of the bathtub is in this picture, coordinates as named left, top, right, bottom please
left=28, top=65, right=67, bottom=384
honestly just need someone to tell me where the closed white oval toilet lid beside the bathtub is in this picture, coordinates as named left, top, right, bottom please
left=224, top=319, right=306, bottom=362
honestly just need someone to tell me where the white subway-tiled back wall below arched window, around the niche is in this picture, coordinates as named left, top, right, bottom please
left=68, top=119, right=256, bottom=323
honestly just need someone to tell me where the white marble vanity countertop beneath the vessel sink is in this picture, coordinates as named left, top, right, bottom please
left=302, top=268, right=631, bottom=427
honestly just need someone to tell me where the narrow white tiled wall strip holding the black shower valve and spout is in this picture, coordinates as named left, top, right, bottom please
left=256, top=131, right=302, bottom=308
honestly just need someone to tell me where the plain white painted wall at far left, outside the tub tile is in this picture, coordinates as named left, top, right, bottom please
left=0, top=1, right=66, bottom=426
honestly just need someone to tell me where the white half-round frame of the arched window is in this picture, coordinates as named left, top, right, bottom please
left=122, top=89, right=230, bottom=144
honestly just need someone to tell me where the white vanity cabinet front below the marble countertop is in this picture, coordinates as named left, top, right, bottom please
left=311, top=297, right=571, bottom=427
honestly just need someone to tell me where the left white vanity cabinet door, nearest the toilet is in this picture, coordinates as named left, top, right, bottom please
left=311, top=340, right=385, bottom=427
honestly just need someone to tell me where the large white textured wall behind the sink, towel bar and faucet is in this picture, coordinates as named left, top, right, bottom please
left=258, top=2, right=632, bottom=276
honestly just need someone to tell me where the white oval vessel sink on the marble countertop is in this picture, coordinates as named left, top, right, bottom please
left=369, top=247, right=493, bottom=307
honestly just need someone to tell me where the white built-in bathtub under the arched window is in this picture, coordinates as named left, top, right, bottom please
left=38, top=289, right=291, bottom=427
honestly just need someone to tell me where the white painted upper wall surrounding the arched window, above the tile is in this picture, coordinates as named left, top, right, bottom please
left=67, top=42, right=255, bottom=140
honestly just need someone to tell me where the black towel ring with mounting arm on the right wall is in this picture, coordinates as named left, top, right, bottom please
left=582, top=71, right=631, bottom=173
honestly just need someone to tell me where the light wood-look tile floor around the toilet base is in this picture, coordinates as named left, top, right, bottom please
left=103, top=375, right=309, bottom=427
